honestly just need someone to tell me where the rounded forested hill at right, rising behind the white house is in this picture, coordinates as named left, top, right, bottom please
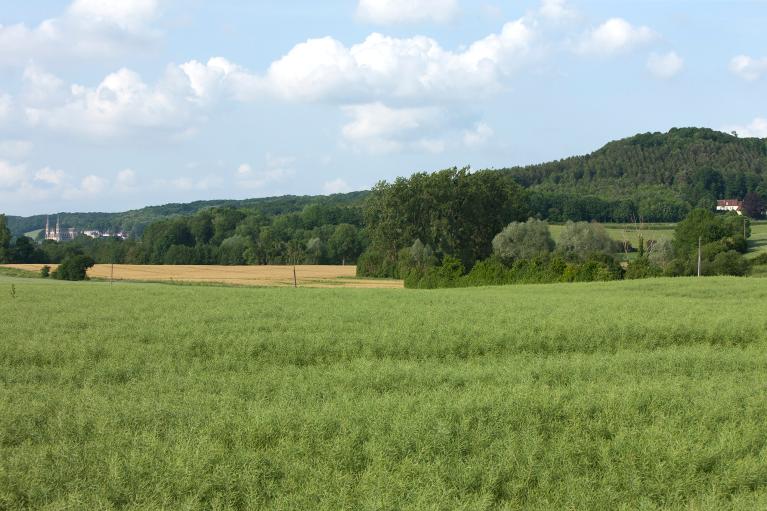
left=512, top=128, right=767, bottom=222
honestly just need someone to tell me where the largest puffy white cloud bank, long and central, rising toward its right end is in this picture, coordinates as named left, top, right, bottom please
left=265, top=20, right=535, bottom=102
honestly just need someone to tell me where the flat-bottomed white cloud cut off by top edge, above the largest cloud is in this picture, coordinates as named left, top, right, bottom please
left=357, top=0, right=459, bottom=25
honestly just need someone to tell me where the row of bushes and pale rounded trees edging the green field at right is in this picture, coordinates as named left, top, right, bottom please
left=397, top=209, right=750, bottom=288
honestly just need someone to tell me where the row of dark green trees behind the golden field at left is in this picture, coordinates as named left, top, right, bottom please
left=0, top=203, right=367, bottom=265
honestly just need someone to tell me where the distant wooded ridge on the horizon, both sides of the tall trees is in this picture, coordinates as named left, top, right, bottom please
left=8, top=128, right=767, bottom=237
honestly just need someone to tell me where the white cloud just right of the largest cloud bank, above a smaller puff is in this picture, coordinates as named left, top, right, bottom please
left=575, top=18, right=658, bottom=55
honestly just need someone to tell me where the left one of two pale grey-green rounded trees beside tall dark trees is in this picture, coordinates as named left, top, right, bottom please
left=493, top=218, right=556, bottom=263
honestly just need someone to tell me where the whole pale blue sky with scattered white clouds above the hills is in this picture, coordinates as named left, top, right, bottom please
left=0, top=0, right=767, bottom=215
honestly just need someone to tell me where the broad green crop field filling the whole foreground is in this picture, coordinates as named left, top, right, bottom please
left=0, top=277, right=767, bottom=510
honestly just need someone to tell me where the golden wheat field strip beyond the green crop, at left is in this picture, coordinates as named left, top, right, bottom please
left=3, top=264, right=403, bottom=288
